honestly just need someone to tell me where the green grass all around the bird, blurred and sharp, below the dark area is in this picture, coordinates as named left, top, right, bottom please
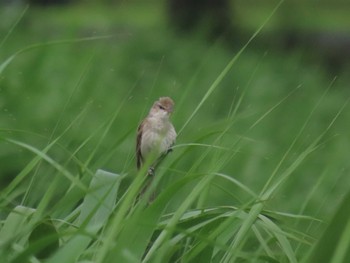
left=0, top=3, right=350, bottom=263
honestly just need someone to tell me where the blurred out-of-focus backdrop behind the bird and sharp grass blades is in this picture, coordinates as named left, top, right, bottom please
left=0, top=0, right=350, bottom=228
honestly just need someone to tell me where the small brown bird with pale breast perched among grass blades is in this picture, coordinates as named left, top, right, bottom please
left=136, top=97, right=176, bottom=175
